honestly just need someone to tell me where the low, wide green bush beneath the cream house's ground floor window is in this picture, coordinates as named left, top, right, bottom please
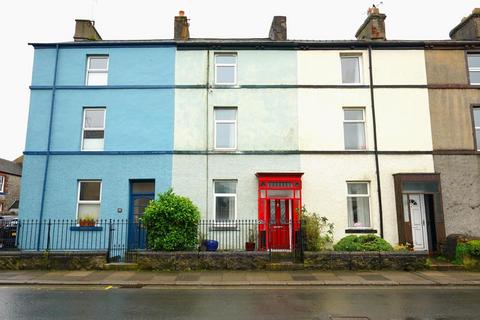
left=333, top=234, right=393, bottom=251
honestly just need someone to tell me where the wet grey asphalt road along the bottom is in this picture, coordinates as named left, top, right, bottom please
left=0, top=287, right=480, bottom=320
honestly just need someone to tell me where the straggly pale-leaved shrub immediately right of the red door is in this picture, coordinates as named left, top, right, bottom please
left=302, top=207, right=334, bottom=251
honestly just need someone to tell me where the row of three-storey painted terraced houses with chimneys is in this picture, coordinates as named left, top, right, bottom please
left=20, top=8, right=480, bottom=255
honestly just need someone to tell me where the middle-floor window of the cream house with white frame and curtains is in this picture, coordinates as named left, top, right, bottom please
left=343, top=108, right=367, bottom=150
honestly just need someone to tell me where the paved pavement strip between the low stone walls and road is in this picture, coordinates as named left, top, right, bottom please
left=0, top=270, right=480, bottom=288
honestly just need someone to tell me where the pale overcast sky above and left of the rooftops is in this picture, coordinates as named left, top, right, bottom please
left=0, top=0, right=480, bottom=160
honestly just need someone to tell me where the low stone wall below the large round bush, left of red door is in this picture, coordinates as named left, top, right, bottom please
left=137, top=251, right=270, bottom=271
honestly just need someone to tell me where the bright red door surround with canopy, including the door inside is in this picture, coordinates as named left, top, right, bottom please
left=256, top=172, right=303, bottom=250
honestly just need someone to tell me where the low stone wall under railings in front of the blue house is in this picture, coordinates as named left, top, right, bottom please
left=0, top=251, right=107, bottom=270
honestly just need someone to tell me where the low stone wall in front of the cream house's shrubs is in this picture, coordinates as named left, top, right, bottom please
left=304, top=251, right=428, bottom=271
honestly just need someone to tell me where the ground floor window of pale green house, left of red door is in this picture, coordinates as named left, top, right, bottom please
left=214, top=180, right=237, bottom=221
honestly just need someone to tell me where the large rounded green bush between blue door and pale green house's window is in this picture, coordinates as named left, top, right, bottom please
left=142, top=189, right=200, bottom=251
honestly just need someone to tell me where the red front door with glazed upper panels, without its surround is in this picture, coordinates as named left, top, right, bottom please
left=267, top=199, right=291, bottom=250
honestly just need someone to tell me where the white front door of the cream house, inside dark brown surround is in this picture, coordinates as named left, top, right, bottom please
left=407, top=193, right=428, bottom=251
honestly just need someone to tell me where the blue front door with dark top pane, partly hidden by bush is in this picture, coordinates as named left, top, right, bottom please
left=128, top=180, right=155, bottom=249
